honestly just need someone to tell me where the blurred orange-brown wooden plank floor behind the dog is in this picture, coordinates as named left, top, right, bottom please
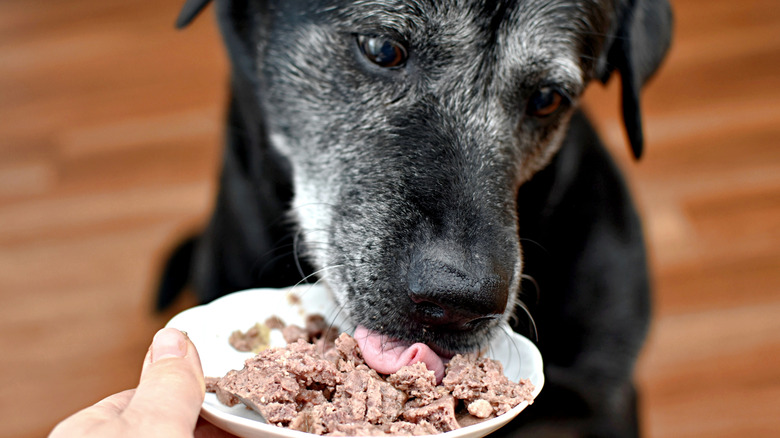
left=0, top=0, right=780, bottom=438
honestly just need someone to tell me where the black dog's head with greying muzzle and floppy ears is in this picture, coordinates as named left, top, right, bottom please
left=178, top=0, right=671, bottom=360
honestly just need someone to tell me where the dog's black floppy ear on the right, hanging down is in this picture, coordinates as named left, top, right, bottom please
left=600, top=0, right=672, bottom=159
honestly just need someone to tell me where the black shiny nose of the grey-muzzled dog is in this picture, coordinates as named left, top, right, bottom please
left=408, top=261, right=509, bottom=330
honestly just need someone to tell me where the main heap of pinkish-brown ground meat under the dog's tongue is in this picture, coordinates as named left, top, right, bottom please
left=206, top=318, right=533, bottom=436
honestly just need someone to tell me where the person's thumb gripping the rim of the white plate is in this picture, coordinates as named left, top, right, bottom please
left=123, top=328, right=205, bottom=437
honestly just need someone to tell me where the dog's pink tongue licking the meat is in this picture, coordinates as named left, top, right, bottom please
left=355, top=325, right=444, bottom=383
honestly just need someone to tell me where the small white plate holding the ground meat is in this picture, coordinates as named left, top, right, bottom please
left=167, top=285, right=544, bottom=438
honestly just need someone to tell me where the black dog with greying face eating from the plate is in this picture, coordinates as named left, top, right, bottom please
left=158, top=0, right=672, bottom=437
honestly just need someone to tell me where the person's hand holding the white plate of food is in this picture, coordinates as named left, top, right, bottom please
left=49, top=328, right=232, bottom=438
